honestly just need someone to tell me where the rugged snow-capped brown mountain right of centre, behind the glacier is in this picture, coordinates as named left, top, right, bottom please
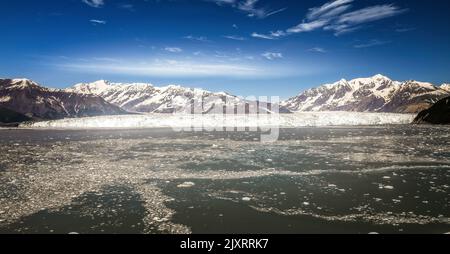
left=281, top=75, right=450, bottom=113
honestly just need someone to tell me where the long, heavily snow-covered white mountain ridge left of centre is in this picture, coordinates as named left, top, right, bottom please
left=66, top=80, right=289, bottom=113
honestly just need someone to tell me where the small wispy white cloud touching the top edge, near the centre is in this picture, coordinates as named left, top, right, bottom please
left=205, top=0, right=287, bottom=18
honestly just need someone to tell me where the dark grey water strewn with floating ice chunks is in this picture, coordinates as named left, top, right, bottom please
left=0, top=126, right=450, bottom=234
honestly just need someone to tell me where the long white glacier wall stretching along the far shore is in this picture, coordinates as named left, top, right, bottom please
left=20, top=112, right=416, bottom=130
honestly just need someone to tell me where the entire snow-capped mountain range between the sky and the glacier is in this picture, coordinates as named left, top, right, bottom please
left=0, top=75, right=450, bottom=122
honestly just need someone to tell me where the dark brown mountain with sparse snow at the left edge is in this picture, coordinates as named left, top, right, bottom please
left=0, top=79, right=127, bottom=119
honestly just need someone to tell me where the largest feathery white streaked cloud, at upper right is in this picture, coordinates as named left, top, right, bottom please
left=253, top=0, right=406, bottom=39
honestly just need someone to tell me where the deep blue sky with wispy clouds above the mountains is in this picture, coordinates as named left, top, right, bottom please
left=0, top=0, right=450, bottom=98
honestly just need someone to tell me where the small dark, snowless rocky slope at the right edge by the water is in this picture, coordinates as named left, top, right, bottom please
left=414, top=97, right=450, bottom=124
